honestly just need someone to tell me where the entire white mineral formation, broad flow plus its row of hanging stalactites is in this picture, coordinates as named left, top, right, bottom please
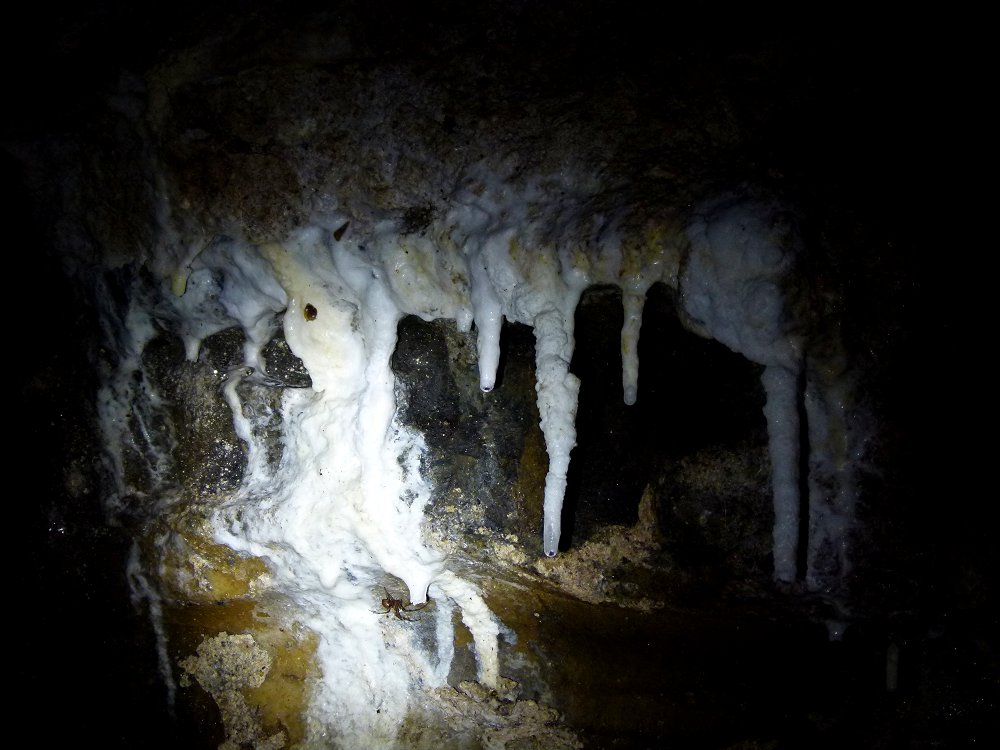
left=104, top=169, right=849, bottom=746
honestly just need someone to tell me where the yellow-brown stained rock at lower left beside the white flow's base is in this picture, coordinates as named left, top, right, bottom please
left=152, top=513, right=318, bottom=747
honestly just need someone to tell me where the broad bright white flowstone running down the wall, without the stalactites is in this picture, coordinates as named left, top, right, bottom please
left=188, top=235, right=454, bottom=747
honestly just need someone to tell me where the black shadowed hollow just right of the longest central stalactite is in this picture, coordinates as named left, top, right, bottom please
left=563, top=284, right=766, bottom=555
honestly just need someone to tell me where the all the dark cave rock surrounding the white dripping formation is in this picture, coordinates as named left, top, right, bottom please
left=3, top=2, right=998, bottom=747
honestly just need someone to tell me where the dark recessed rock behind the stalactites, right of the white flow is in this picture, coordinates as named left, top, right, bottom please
left=393, top=287, right=773, bottom=575
